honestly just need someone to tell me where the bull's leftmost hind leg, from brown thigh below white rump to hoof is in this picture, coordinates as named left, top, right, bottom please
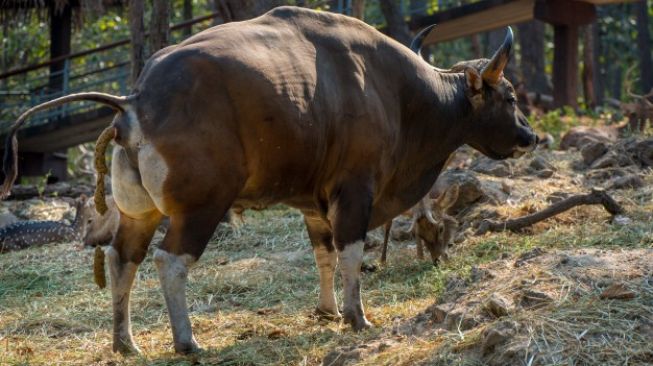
left=106, top=213, right=161, bottom=354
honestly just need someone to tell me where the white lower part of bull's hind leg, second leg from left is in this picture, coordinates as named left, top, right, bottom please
left=154, top=249, right=199, bottom=353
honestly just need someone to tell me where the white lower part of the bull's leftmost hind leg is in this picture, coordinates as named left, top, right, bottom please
left=106, top=247, right=140, bottom=354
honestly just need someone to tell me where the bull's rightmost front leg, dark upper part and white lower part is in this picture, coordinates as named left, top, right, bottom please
left=328, top=183, right=372, bottom=330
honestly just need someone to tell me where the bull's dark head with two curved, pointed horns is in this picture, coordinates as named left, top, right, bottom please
left=411, top=26, right=538, bottom=159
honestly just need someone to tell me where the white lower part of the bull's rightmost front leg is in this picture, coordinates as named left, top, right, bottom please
left=338, top=240, right=371, bottom=330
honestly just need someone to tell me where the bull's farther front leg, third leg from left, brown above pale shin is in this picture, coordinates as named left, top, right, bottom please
left=304, top=213, right=340, bottom=319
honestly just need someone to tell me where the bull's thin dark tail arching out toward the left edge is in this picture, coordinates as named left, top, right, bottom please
left=0, top=92, right=132, bottom=200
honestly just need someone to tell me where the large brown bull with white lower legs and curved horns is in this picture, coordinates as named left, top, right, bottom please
left=0, top=7, right=536, bottom=353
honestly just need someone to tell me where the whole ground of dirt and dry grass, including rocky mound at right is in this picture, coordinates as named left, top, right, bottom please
left=0, top=129, right=653, bottom=365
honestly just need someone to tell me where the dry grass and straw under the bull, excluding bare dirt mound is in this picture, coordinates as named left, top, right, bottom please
left=0, top=149, right=653, bottom=365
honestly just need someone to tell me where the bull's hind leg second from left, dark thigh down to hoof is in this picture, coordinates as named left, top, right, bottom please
left=154, top=205, right=229, bottom=354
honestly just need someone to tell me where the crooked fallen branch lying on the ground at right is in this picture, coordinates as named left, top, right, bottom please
left=475, top=188, right=623, bottom=235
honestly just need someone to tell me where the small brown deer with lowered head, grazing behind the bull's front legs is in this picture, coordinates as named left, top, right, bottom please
left=381, top=184, right=459, bottom=265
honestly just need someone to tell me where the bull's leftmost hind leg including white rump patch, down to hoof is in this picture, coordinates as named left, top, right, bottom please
left=106, top=146, right=161, bottom=354
